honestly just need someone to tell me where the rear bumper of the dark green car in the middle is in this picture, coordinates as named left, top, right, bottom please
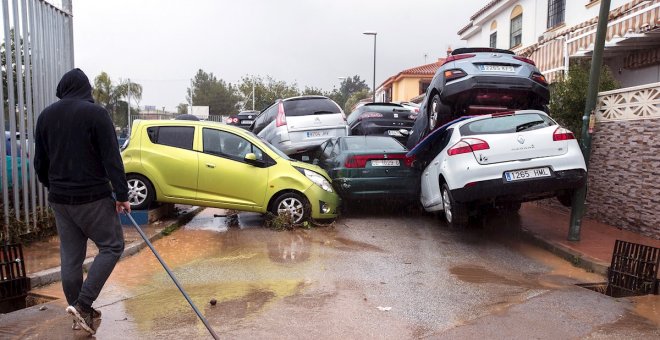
left=332, top=176, right=419, bottom=199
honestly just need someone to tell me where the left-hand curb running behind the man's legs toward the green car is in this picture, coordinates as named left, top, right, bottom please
left=29, top=207, right=204, bottom=289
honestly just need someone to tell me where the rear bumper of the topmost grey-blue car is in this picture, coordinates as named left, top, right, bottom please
left=441, top=75, right=550, bottom=102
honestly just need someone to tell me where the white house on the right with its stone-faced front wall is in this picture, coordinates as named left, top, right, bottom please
left=458, top=0, right=660, bottom=239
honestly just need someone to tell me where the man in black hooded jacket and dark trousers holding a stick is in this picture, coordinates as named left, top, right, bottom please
left=33, top=68, right=130, bottom=334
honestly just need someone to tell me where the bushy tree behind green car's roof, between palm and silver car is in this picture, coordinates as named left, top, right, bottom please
left=186, top=69, right=240, bottom=115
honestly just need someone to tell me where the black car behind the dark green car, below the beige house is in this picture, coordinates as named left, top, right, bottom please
left=346, top=103, right=417, bottom=145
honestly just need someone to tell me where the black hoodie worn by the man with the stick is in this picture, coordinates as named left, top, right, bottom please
left=33, top=68, right=128, bottom=204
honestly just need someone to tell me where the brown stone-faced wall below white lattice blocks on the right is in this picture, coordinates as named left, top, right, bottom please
left=587, top=119, right=660, bottom=239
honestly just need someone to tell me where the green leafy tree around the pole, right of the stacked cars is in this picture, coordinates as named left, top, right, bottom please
left=550, top=61, right=619, bottom=138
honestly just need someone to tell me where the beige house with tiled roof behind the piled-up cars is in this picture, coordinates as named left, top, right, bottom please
left=376, top=58, right=445, bottom=102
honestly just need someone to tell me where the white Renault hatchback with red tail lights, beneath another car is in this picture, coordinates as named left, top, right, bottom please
left=418, top=110, right=587, bottom=226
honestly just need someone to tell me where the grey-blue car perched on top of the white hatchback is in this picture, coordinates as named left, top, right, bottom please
left=407, top=48, right=550, bottom=149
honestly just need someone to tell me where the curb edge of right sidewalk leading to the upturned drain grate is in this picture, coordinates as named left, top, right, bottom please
left=521, top=227, right=609, bottom=276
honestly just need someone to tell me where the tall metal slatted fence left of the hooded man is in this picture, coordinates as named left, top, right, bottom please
left=0, top=0, right=73, bottom=238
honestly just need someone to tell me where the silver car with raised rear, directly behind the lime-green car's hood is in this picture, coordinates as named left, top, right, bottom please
left=252, top=96, right=349, bottom=155
